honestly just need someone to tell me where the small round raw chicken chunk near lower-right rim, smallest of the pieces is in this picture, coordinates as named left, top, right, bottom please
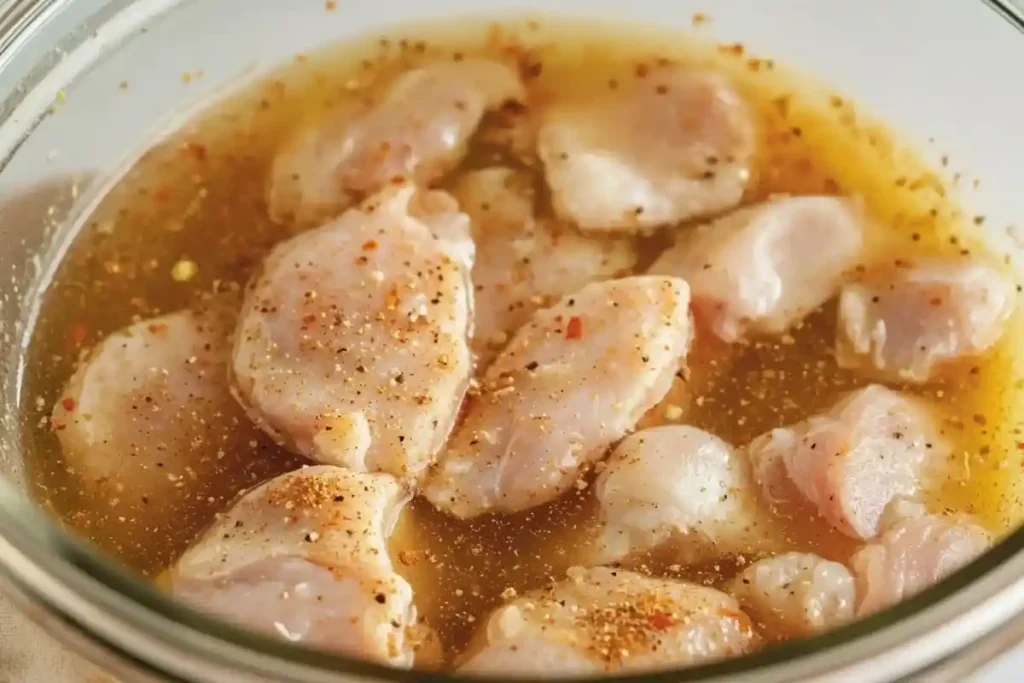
left=729, top=553, right=857, bottom=636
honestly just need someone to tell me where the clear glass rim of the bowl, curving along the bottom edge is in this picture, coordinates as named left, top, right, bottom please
left=0, top=0, right=1024, bottom=683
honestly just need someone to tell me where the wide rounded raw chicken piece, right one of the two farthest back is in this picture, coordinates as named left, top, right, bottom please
left=538, top=68, right=756, bottom=230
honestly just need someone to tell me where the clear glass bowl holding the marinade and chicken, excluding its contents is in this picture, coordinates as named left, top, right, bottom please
left=0, top=0, right=1024, bottom=683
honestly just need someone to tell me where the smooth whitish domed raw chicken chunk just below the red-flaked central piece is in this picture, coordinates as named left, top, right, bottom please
left=594, top=425, right=769, bottom=564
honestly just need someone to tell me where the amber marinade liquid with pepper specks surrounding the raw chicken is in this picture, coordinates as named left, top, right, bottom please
left=23, top=15, right=1021, bottom=667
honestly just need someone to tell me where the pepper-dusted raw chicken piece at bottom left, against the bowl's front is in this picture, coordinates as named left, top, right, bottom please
left=171, top=466, right=422, bottom=667
